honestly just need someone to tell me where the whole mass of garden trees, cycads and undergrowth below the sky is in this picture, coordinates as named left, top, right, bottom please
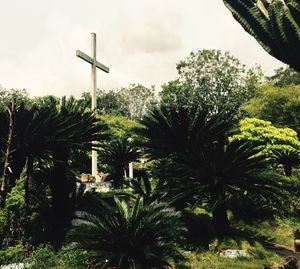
left=0, top=44, right=300, bottom=269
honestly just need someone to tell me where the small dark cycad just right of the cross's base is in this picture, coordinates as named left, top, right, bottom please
left=99, top=137, right=140, bottom=188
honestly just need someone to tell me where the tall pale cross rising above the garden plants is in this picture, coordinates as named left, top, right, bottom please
left=76, top=33, right=109, bottom=177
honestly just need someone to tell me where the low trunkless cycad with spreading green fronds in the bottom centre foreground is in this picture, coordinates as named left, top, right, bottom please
left=69, top=195, right=184, bottom=269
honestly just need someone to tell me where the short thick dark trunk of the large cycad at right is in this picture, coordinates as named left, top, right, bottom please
left=212, top=202, right=230, bottom=236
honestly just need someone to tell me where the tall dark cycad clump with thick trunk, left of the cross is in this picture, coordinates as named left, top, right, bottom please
left=0, top=98, right=106, bottom=241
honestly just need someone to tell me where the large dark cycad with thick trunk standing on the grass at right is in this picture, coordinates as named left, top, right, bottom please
left=187, top=138, right=290, bottom=236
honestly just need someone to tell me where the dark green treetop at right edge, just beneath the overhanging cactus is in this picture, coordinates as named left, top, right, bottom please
left=267, top=67, right=300, bottom=88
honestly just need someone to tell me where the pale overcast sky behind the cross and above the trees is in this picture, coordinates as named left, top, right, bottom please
left=0, top=0, right=282, bottom=96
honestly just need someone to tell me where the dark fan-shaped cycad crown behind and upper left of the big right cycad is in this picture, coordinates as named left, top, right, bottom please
left=136, top=105, right=233, bottom=159
